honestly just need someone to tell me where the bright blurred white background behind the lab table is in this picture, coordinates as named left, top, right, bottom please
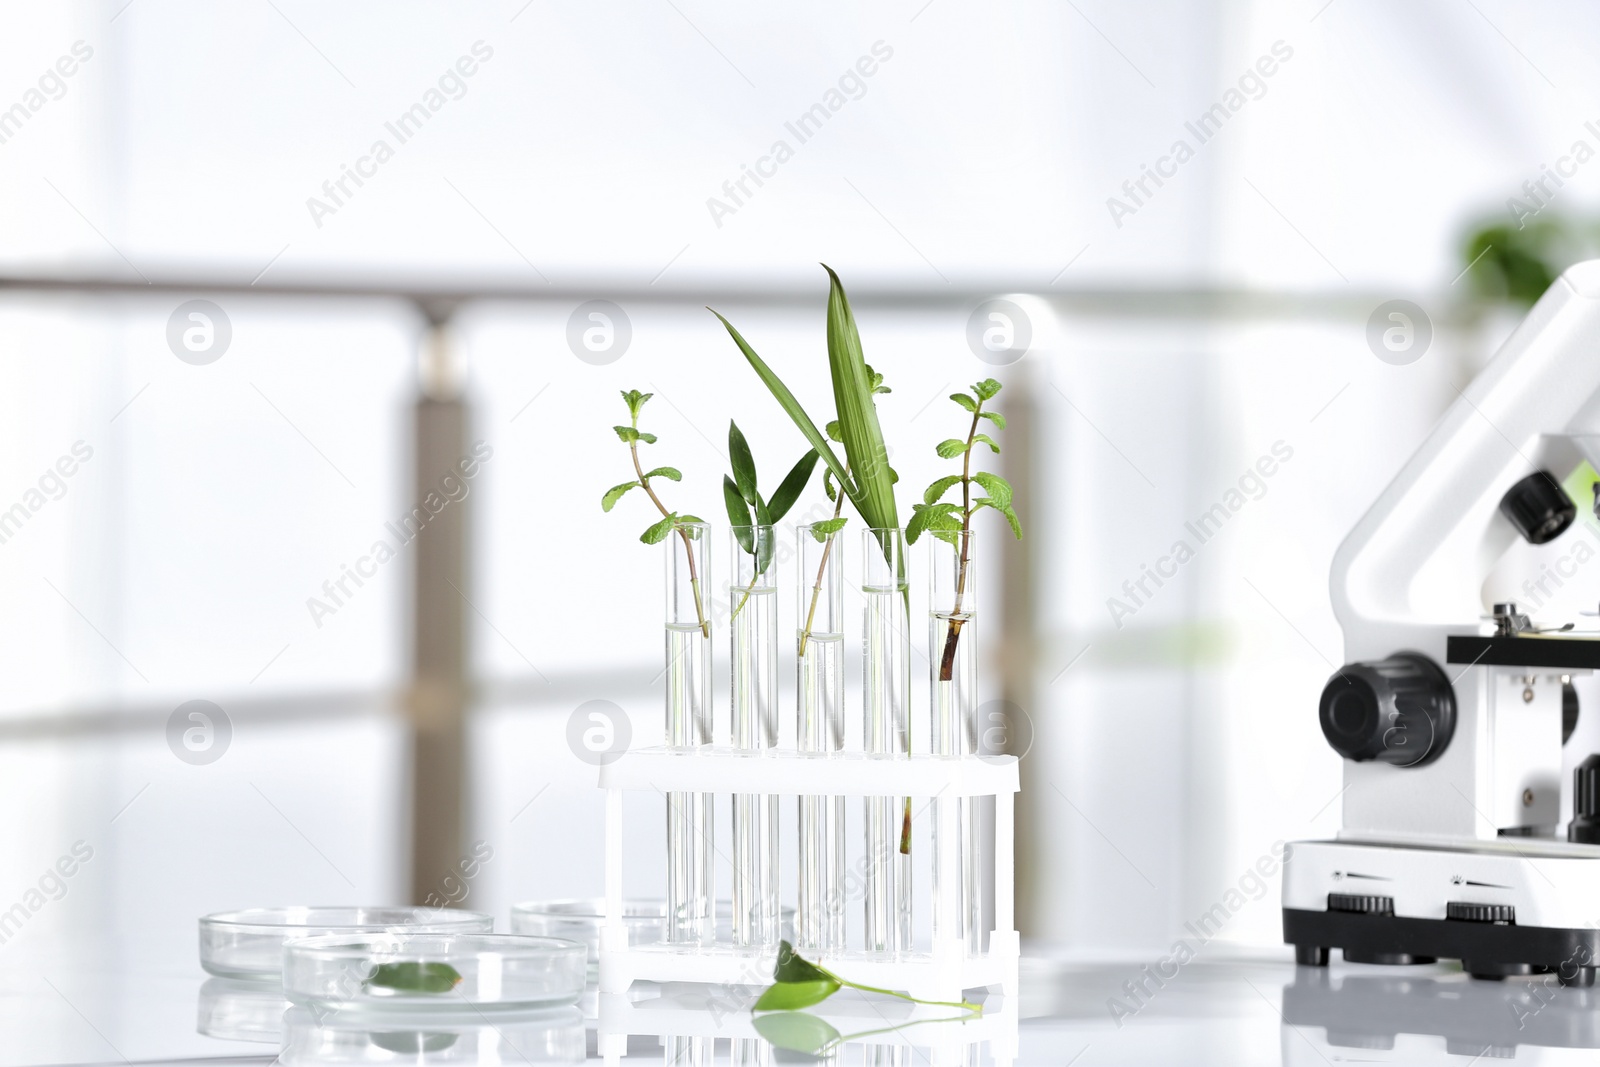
left=0, top=0, right=1580, bottom=1011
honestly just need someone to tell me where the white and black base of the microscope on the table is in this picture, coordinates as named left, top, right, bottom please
left=1283, top=840, right=1600, bottom=987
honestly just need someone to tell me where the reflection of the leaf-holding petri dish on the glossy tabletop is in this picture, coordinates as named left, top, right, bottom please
left=278, top=1008, right=587, bottom=1067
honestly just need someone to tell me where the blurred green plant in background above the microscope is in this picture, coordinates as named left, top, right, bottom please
left=1461, top=216, right=1600, bottom=307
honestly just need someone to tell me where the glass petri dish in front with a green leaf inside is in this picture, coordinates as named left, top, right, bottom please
left=283, top=931, right=589, bottom=1017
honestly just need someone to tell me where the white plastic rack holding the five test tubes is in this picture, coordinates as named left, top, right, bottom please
left=600, top=745, right=1019, bottom=1001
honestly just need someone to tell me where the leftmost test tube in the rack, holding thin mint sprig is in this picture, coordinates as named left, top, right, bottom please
left=662, top=523, right=715, bottom=944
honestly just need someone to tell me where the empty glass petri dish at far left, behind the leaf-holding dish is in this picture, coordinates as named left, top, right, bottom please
left=200, top=907, right=494, bottom=982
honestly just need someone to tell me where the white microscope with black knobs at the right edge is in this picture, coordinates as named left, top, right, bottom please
left=1283, top=261, right=1600, bottom=987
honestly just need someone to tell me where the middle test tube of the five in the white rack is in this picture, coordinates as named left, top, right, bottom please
left=795, top=526, right=845, bottom=952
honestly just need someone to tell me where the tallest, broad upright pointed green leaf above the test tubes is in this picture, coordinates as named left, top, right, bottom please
left=822, top=264, right=899, bottom=530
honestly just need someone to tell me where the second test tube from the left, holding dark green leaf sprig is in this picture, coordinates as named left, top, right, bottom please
left=728, top=526, right=779, bottom=945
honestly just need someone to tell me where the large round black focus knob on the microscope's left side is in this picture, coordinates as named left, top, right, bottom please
left=1318, top=653, right=1456, bottom=766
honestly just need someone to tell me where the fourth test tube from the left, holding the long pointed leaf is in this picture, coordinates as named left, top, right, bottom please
left=861, top=530, right=910, bottom=952
